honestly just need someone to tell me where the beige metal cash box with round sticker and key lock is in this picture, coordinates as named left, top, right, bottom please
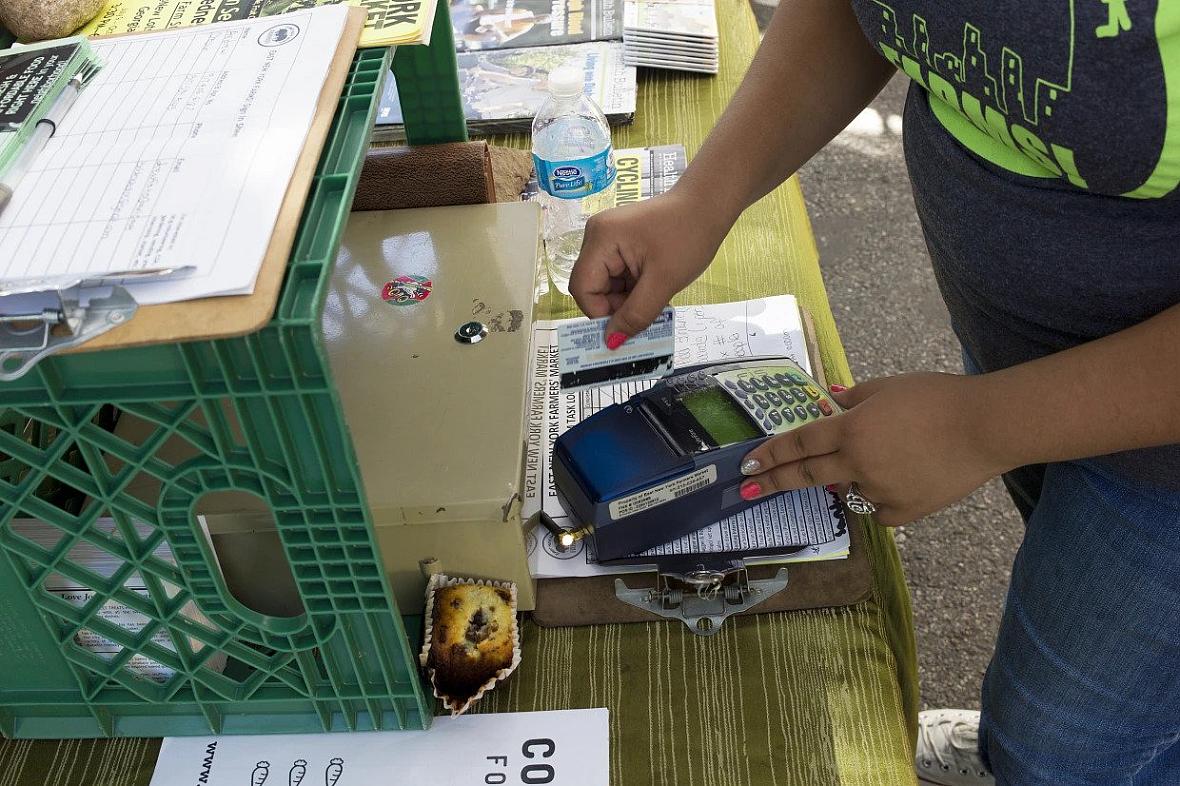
left=116, top=203, right=540, bottom=615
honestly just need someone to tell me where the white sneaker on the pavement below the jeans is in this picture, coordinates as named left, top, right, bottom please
left=913, top=709, right=996, bottom=786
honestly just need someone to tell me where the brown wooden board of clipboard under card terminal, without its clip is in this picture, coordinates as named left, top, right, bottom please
left=532, top=310, right=873, bottom=628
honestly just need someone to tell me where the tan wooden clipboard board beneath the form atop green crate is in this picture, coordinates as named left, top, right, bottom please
left=63, top=7, right=365, bottom=354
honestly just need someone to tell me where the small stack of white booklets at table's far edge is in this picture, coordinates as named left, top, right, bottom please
left=623, top=0, right=717, bottom=73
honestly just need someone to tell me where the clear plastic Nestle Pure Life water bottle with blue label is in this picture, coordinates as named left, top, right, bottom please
left=532, top=67, right=615, bottom=295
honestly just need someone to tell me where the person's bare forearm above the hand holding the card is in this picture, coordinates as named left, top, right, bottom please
left=677, top=0, right=894, bottom=227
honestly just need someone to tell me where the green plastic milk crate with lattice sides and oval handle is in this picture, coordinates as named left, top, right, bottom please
left=0, top=50, right=431, bottom=738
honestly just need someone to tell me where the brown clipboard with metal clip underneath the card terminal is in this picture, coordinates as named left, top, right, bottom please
left=532, top=309, right=873, bottom=635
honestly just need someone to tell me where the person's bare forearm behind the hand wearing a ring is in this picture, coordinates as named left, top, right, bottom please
left=978, top=304, right=1180, bottom=467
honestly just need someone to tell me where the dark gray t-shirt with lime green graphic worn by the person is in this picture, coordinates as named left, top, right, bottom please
left=852, top=0, right=1180, bottom=490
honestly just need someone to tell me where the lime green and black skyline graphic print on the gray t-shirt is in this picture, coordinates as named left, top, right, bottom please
left=853, top=0, right=1180, bottom=198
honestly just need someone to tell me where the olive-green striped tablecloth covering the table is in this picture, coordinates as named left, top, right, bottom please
left=0, top=0, right=918, bottom=786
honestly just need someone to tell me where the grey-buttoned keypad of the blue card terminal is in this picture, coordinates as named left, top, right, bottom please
left=715, top=366, right=837, bottom=434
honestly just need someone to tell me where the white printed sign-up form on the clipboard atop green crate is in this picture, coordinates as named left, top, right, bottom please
left=0, top=6, right=354, bottom=306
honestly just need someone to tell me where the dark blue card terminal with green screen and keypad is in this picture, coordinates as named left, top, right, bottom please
left=553, top=358, right=840, bottom=562
